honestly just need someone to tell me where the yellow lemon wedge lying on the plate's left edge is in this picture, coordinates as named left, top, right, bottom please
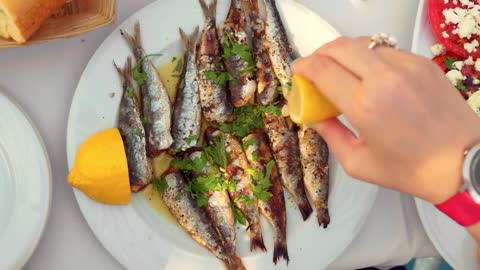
left=68, top=128, right=131, bottom=205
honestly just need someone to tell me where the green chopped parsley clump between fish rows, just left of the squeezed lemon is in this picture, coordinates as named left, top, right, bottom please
left=219, top=105, right=282, bottom=138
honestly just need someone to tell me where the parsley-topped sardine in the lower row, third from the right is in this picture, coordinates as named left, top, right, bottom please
left=243, top=131, right=290, bottom=264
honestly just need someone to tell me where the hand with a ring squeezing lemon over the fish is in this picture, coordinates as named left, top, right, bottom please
left=293, top=37, right=480, bottom=204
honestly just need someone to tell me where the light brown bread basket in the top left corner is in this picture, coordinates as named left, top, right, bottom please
left=0, top=0, right=117, bottom=49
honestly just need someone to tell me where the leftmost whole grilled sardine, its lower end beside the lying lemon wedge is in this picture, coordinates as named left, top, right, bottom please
left=114, top=57, right=153, bottom=192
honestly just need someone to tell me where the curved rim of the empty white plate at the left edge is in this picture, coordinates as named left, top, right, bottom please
left=0, top=88, right=53, bottom=269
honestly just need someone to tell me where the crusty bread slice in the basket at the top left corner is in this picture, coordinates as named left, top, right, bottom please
left=0, top=0, right=65, bottom=44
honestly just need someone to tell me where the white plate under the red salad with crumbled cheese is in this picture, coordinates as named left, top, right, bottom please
left=412, top=0, right=480, bottom=269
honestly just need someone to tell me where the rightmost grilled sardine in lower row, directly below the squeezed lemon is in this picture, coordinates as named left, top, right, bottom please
left=298, top=128, right=330, bottom=228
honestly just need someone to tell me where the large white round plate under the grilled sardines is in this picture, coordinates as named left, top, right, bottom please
left=67, top=0, right=377, bottom=269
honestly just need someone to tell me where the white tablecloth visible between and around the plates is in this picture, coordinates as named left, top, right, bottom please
left=0, top=0, right=437, bottom=270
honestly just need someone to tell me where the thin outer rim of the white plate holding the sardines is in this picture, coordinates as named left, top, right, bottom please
left=66, top=0, right=379, bottom=267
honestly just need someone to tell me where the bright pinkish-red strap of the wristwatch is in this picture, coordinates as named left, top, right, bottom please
left=436, top=191, right=480, bottom=227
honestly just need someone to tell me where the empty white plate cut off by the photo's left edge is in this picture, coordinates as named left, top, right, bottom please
left=0, top=91, right=52, bottom=269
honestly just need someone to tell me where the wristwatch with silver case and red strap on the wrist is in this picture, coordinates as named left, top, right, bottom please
left=436, top=144, right=480, bottom=227
